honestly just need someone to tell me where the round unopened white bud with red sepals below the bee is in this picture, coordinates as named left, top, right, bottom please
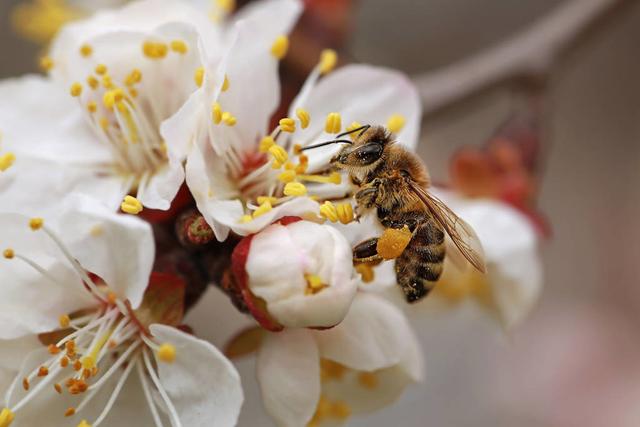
left=232, top=218, right=358, bottom=330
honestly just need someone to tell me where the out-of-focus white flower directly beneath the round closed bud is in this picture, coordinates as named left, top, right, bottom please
left=256, top=292, right=423, bottom=427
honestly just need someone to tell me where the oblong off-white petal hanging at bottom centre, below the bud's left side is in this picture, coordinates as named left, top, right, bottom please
left=256, top=329, right=320, bottom=427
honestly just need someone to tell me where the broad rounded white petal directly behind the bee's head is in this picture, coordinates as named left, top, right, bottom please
left=289, top=65, right=422, bottom=171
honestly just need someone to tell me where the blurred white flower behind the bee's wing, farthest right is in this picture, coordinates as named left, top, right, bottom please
left=424, top=192, right=542, bottom=330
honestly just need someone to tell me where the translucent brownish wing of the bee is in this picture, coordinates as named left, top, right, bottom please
left=409, top=180, right=485, bottom=273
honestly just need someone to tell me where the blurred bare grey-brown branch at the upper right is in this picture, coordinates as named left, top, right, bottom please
left=414, top=0, right=624, bottom=114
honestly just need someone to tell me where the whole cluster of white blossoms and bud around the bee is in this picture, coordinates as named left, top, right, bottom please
left=0, top=0, right=541, bottom=427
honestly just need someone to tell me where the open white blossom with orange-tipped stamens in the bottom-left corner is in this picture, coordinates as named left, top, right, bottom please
left=0, top=198, right=243, bottom=427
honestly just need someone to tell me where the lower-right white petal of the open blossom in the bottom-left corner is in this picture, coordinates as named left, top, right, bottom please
left=150, top=324, right=243, bottom=427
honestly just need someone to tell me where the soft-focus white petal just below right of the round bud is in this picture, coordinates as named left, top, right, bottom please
left=314, top=292, right=417, bottom=375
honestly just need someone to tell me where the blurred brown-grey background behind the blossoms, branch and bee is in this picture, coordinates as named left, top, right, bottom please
left=0, top=0, right=640, bottom=427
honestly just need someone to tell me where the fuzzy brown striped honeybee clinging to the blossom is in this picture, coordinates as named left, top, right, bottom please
left=303, top=125, right=485, bottom=303
